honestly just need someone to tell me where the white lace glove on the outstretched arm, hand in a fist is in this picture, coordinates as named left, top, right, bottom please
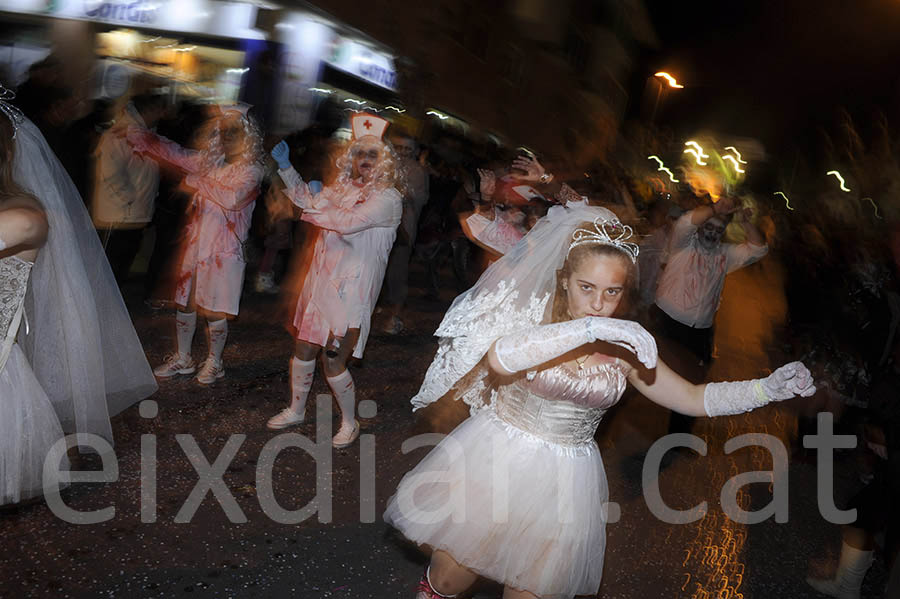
left=703, top=362, right=816, bottom=416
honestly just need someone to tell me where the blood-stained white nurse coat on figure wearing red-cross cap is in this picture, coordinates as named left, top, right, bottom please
left=278, top=169, right=403, bottom=358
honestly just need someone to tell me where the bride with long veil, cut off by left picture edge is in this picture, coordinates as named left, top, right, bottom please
left=0, top=86, right=156, bottom=464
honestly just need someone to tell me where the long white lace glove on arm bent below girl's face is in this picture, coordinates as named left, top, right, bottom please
left=494, top=316, right=657, bottom=373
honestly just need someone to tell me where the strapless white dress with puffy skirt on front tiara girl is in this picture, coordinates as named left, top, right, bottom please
left=384, top=360, right=628, bottom=599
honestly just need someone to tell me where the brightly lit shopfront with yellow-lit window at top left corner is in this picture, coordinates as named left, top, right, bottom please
left=0, top=0, right=266, bottom=101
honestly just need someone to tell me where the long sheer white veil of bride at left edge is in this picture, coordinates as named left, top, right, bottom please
left=13, top=119, right=157, bottom=441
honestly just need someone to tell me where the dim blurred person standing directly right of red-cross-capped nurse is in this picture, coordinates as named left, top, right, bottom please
left=383, top=131, right=429, bottom=335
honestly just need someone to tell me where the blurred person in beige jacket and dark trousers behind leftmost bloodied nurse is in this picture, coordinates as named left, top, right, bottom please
left=92, top=94, right=166, bottom=286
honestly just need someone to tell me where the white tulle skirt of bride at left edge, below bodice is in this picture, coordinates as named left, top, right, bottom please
left=0, top=344, right=68, bottom=505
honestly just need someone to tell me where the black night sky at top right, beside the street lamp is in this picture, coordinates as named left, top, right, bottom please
left=642, top=0, right=900, bottom=154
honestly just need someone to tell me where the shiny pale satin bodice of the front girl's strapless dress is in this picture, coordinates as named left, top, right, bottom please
left=494, top=361, right=627, bottom=446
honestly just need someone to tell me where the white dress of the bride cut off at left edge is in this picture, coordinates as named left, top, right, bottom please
left=0, top=256, right=67, bottom=505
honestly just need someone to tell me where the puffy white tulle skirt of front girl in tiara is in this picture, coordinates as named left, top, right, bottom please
left=384, top=410, right=609, bottom=599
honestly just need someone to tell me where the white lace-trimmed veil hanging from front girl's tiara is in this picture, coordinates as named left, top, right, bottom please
left=411, top=204, right=618, bottom=412
